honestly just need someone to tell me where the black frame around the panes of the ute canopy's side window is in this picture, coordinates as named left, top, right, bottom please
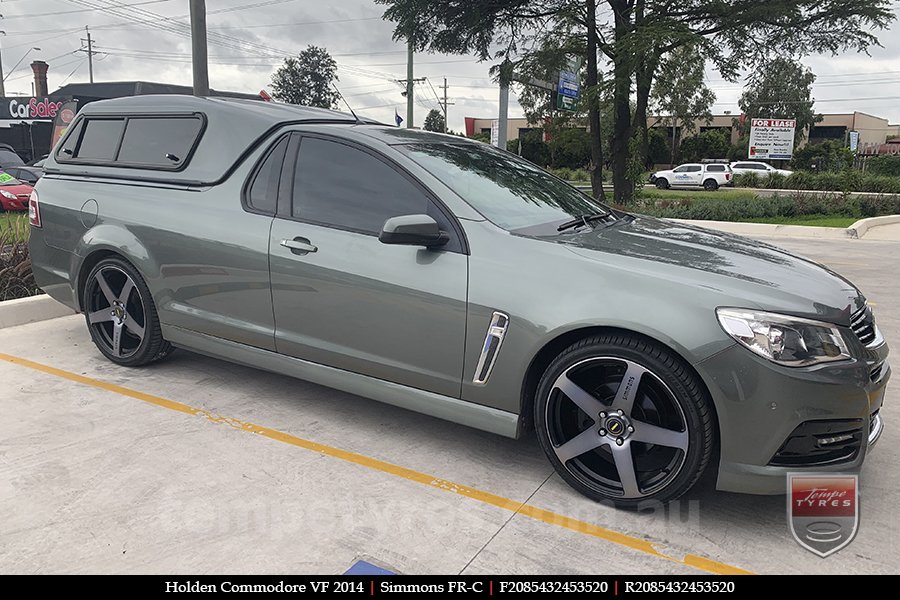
left=53, top=112, right=208, bottom=173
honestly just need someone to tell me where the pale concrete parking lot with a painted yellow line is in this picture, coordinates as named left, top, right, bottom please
left=0, top=232, right=900, bottom=574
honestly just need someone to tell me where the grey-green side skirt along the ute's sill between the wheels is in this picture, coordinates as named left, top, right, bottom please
left=163, top=325, right=519, bottom=438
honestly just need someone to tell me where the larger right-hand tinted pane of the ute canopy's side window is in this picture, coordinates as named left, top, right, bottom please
left=117, top=117, right=203, bottom=167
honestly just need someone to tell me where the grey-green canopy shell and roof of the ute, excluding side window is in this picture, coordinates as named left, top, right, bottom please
left=45, top=95, right=377, bottom=184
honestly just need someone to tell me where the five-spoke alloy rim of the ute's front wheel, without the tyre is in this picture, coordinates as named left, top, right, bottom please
left=538, top=355, right=705, bottom=504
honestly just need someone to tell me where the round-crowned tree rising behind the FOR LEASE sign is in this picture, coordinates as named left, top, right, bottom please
left=738, top=58, right=822, bottom=144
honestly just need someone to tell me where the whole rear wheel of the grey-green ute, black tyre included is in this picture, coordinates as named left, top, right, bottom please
left=82, top=258, right=173, bottom=367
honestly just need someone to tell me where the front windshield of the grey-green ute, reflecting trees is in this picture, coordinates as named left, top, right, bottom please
left=396, top=143, right=607, bottom=235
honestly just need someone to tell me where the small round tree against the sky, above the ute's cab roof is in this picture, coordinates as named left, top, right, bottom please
left=272, top=46, right=340, bottom=109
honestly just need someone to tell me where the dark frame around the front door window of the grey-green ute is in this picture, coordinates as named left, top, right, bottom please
left=275, top=131, right=470, bottom=255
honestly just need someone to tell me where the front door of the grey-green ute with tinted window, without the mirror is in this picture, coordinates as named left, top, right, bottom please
left=269, top=134, right=468, bottom=397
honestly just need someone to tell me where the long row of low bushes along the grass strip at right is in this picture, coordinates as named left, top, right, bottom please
left=628, top=192, right=900, bottom=221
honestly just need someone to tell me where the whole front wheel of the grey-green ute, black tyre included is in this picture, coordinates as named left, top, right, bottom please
left=534, top=334, right=715, bottom=509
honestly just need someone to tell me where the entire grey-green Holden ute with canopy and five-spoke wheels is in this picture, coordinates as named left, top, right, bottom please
left=30, top=96, right=891, bottom=508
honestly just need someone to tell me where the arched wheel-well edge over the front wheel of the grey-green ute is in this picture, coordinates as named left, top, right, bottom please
left=519, top=325, right=719, bottom=442
